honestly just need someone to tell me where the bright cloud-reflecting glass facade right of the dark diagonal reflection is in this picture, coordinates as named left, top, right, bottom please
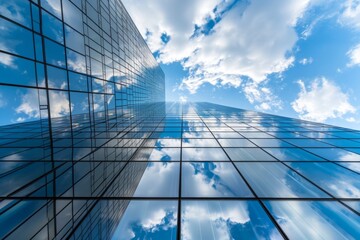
left=108, top=103, right=360, bottom=240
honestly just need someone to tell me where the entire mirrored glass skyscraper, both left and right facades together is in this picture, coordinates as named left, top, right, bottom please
left=0, top=0, right=360, bottom=239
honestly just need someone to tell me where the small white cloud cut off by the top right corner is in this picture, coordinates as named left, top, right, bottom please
left=339, top=0, right=360, bottom=29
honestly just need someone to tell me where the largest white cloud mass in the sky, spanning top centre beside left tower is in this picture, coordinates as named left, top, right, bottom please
left=123, top=0, right=309, bottom=103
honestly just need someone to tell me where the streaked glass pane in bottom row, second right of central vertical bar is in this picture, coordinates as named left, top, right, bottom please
left=265, top=201, right=360, bottom=239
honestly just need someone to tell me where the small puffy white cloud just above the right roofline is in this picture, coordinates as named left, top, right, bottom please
left=291, top=78, right=356, bottom=122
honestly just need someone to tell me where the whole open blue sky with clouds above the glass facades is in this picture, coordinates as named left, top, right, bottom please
left=123, top=0, right=360, bottom=129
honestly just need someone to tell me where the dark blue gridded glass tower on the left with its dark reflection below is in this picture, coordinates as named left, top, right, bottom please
left=0, top=0, right=165, bottom=239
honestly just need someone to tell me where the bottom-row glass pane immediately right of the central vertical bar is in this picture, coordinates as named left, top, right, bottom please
left=181, top=201, right=283, bottom=240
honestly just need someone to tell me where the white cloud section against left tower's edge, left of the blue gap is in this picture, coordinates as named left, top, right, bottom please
left=123, top=0, right=221, bottom=63
